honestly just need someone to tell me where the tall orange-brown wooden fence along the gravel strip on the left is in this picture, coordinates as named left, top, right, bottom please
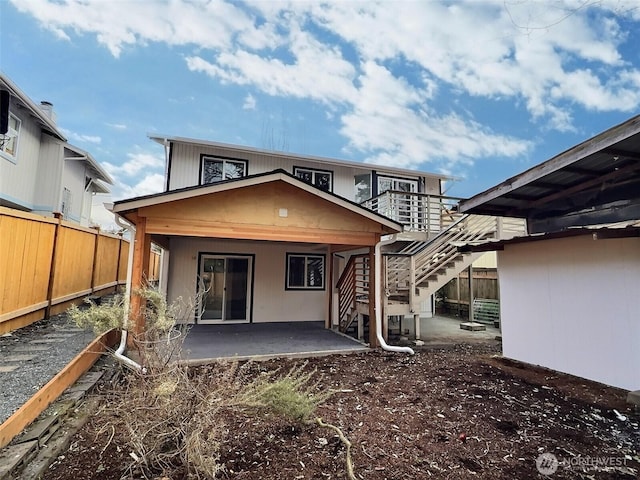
left=0, top=207, right=160, bottom=334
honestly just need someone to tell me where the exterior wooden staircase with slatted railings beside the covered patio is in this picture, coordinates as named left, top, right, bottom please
left=337, top=215, right=526, bottom=336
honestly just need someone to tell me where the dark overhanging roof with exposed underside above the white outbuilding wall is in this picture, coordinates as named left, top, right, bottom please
left=460, top=115, right=640, bottom=231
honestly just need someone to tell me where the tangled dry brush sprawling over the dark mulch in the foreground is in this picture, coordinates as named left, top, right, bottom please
left=104, top=362, right=329, bottom=479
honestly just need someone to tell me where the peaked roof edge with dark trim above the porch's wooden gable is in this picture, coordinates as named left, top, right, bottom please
left=112, top=169, right=404, bottom=232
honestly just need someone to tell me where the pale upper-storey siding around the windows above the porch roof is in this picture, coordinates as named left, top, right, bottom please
left=169, top=143, right=440, bottom=201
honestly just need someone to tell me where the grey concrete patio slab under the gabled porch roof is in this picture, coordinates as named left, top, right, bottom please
left=183, top=322, right=369, bottom=365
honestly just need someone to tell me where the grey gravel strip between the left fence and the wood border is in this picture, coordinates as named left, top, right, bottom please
left=0, top=314, right=95, bottom=423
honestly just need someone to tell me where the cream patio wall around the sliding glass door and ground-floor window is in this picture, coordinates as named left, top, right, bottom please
left=168, top=238, right=329, bottom=323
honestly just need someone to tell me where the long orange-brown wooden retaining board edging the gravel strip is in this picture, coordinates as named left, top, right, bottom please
left=0, top=330, right=120, bottom=448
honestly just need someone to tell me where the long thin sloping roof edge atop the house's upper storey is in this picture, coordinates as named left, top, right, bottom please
left=148, top=135, right=456, bottom=180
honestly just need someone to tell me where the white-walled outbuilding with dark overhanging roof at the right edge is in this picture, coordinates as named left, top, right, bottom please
left=460, top=116, right=640, bottom=390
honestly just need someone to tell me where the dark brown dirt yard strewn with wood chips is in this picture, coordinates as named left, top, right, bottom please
left=44, top=345, right=640, bottom=480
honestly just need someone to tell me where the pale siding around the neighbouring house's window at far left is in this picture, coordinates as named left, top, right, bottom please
left=0, top=98, right=40, bottom=209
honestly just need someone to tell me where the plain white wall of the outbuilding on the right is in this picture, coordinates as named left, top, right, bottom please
left=498, top=236, right=640, bottom=390
